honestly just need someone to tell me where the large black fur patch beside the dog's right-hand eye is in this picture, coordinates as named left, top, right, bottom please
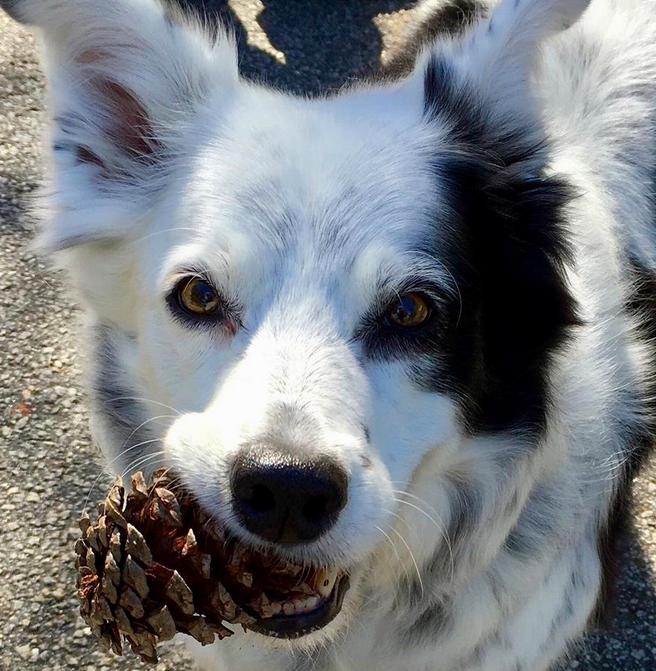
left=417, top=57, right=579, bottom=433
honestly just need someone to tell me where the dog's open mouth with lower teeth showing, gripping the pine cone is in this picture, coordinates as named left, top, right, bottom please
left=219, top=543, right=349, bottom=639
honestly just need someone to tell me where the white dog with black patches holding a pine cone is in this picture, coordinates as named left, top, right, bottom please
left=2, top=0, right=656, bottom=671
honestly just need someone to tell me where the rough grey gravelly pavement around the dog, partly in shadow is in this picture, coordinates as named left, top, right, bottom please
left=0, top=0, right=656, bottom=671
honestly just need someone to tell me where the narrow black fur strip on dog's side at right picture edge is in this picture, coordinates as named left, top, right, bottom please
left=591, top=259, right=656, bottom=628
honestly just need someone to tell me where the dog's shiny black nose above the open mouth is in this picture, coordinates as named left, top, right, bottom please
left=230, top=445, right=348, bottom=544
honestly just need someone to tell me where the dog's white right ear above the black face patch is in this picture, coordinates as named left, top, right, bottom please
left=434, top=0, right=590, bottom=114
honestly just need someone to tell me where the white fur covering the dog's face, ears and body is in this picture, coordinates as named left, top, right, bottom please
left=9, top=0, right=656, bottom=671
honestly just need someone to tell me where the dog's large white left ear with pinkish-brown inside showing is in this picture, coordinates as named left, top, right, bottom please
left=0, top=0, right=238, bottom=248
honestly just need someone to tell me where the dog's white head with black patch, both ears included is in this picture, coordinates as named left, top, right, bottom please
left=4, top=0, right=587, bottom=637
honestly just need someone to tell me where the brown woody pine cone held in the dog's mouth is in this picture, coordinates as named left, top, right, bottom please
left=75, top=469, right=260, bottom=663
